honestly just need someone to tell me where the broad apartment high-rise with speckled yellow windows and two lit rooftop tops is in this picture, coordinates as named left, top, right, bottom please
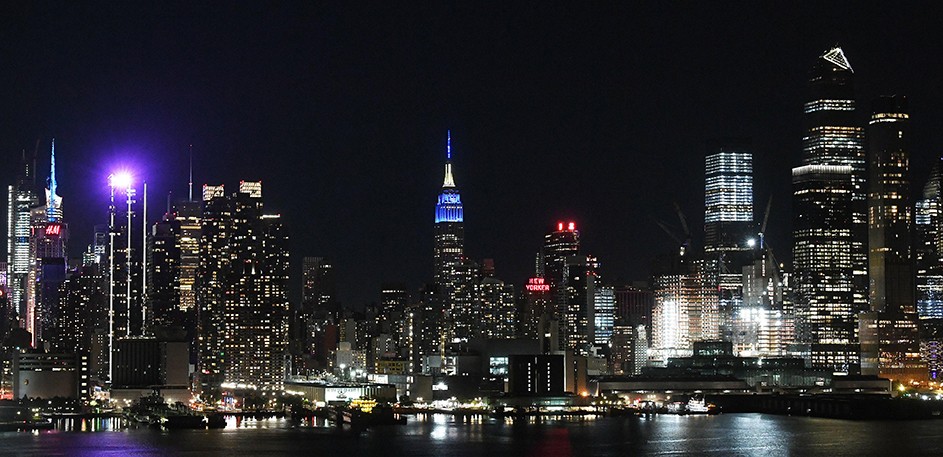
left=197, top=183, right=288, bottom=397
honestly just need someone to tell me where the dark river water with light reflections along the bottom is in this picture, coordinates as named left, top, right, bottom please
left=0, top=414, right=943, bottom=457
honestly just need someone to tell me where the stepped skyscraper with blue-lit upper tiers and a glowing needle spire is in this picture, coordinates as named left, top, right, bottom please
left=433, top=132, right=475, bottom=342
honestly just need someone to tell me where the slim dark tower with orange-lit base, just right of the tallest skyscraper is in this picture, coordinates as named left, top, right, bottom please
left=859, top=96, right=927, bottom=380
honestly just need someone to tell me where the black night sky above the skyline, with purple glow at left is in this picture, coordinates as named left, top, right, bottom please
left=0, top=2, right=943, bottom=306
